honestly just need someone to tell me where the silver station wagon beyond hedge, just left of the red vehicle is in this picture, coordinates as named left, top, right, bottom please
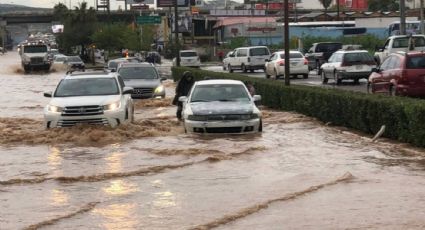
left=320, top=50, right=376, bottom=85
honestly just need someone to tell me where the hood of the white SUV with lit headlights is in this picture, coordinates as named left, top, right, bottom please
left=50, top=95, right=121, bottom=107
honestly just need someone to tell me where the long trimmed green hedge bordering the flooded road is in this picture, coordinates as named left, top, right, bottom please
left=172, top=67, right=425, bottom=147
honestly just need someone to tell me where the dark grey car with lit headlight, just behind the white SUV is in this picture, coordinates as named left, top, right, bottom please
left=117, top=63, right=166, bottom=98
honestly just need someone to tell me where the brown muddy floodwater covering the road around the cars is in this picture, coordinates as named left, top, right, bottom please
left=0, top=52, right=425, bottom=230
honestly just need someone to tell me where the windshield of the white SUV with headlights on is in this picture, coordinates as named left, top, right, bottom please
left=55, top=78, right=120, bottom=97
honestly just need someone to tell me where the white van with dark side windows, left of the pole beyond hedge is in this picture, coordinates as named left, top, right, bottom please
left=227, top=46, right=270, bottom=73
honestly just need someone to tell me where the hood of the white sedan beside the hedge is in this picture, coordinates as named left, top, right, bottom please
left=190, top=101, right=254, bottom=115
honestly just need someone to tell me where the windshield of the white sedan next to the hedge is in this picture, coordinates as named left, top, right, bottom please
left=191, top=84, right=250, bottom=102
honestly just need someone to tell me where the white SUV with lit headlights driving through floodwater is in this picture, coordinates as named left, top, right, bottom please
left=44, top=71, right=134, bottom=128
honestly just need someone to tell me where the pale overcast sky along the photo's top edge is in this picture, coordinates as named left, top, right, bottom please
left=4, top=0, right=321, bottom=9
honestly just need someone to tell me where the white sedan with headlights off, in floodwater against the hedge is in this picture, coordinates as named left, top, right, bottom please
left=179, top=80, right=263, bottom=133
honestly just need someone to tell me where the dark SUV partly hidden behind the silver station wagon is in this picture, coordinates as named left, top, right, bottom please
left=305, top=42, right=342, bottom=75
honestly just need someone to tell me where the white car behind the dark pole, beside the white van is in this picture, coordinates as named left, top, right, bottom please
left=264, top=51, right=309, bottom=79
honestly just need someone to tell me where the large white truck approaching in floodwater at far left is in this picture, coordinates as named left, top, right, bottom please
left=19, top=42, right=52, bottom=73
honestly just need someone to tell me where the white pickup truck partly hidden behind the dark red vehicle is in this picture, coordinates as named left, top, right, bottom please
left=374, top=34, right=425, bottom=64
